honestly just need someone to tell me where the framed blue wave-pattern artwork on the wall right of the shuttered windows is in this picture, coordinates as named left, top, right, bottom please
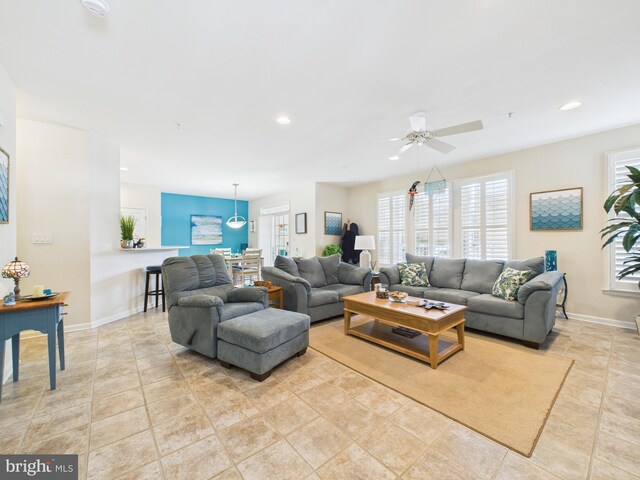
left=530, top=187, right=582, bottom=230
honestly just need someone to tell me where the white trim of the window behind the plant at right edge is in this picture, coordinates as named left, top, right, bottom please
left=602, top=147, right=640, bottom=297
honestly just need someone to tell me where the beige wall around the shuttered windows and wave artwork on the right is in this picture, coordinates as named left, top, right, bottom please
left=348, top=125, right=640, bottom=322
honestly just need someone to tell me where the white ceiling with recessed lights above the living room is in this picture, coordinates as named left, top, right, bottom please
left=0, top=0, right=640, bottom=199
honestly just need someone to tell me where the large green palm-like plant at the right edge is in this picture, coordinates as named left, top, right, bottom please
left=600, top=166, right=640, bottom=333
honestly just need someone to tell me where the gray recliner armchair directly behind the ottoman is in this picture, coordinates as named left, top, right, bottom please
left=162, top=255, right=268, bottom=358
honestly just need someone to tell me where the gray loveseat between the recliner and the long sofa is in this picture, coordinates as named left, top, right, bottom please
left=262, top=254, right=371, bottom=322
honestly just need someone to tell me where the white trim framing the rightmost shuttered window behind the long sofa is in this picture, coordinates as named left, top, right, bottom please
left=451, top=170, right=515, bottom=260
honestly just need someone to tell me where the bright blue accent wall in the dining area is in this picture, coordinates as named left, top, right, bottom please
left=160, top=193, right=249, bottom=256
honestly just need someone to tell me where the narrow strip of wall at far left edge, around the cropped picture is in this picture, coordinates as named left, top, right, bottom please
left=0, top=64, right=18, bottom=382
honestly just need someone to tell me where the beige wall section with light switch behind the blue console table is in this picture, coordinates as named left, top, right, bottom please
left=18, top=119, right=91, bottom=325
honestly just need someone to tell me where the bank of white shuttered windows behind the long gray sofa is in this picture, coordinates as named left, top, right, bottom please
left=376, top=171, right=513, bottom=265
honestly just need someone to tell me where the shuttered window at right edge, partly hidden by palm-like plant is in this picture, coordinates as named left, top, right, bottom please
left=606, top=148, right=640, bottom=293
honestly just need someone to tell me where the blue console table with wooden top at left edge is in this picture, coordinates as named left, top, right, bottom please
left=0, top=292, right=69, bottom=402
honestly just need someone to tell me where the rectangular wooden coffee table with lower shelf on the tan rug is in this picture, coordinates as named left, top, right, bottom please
left=342, top=292, right=467, bottom=369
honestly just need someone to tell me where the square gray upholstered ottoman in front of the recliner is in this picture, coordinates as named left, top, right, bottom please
left=218, top=308, right=310, bottom=382
